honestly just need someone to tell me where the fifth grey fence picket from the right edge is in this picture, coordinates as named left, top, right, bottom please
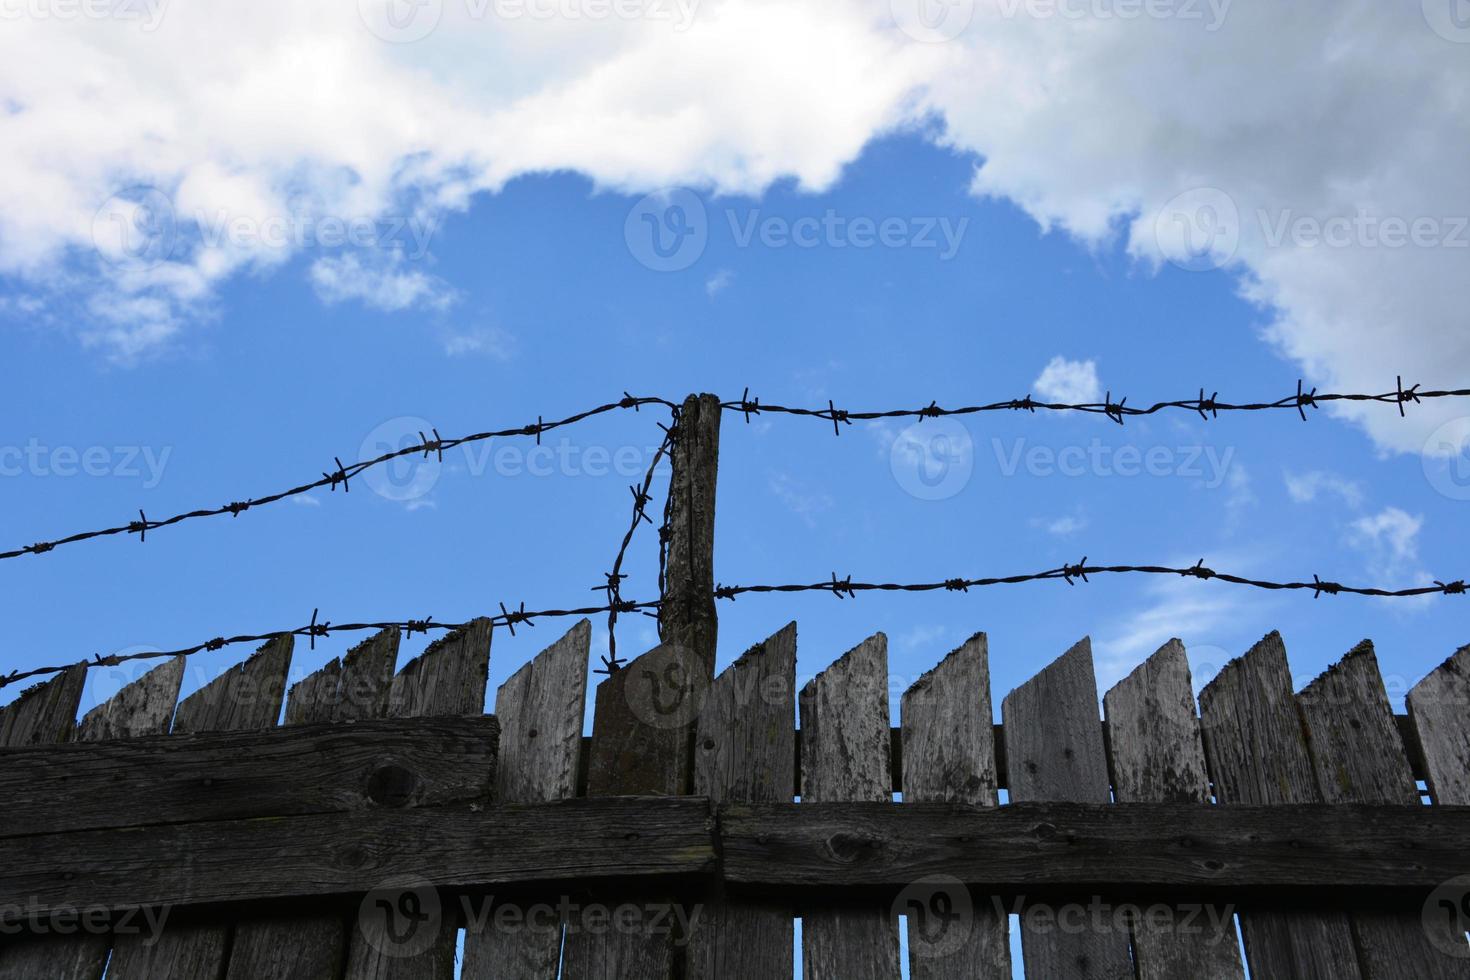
left=1001, top=638, right=1133, bottom=980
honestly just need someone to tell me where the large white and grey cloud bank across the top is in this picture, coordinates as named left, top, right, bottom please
left=0, top=0, right=1470, bottom=451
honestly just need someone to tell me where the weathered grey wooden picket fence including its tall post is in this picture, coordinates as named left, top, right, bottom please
left=0, top=393, right=1470, bottom=980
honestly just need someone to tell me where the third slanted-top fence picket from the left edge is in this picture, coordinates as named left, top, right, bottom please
left=105, top=635, right=295, bottom=980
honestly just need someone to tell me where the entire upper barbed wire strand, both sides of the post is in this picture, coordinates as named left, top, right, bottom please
left=0, top=378, right=1470, bottom=570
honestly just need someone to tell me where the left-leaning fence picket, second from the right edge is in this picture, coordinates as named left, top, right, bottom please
left=1297, top=641, right=1470, bottom=980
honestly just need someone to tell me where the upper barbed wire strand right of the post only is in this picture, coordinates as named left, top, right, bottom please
left=720, top=376, right=1470, bottom=435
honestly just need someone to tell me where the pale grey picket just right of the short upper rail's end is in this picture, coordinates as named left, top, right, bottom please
left=460, top=620, right=592, bottom=980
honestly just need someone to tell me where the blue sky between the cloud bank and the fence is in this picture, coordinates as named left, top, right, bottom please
left=0, top=131, right=1467, bottom=717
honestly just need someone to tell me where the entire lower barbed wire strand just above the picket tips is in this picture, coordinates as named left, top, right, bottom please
left=0, top=557, right=1470, bottom=688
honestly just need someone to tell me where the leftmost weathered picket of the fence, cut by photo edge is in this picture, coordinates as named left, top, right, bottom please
left=0, top=667, right=100, bottom=980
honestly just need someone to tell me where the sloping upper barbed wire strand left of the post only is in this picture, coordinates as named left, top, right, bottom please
left=0, top=391, right=676, bottom=560
